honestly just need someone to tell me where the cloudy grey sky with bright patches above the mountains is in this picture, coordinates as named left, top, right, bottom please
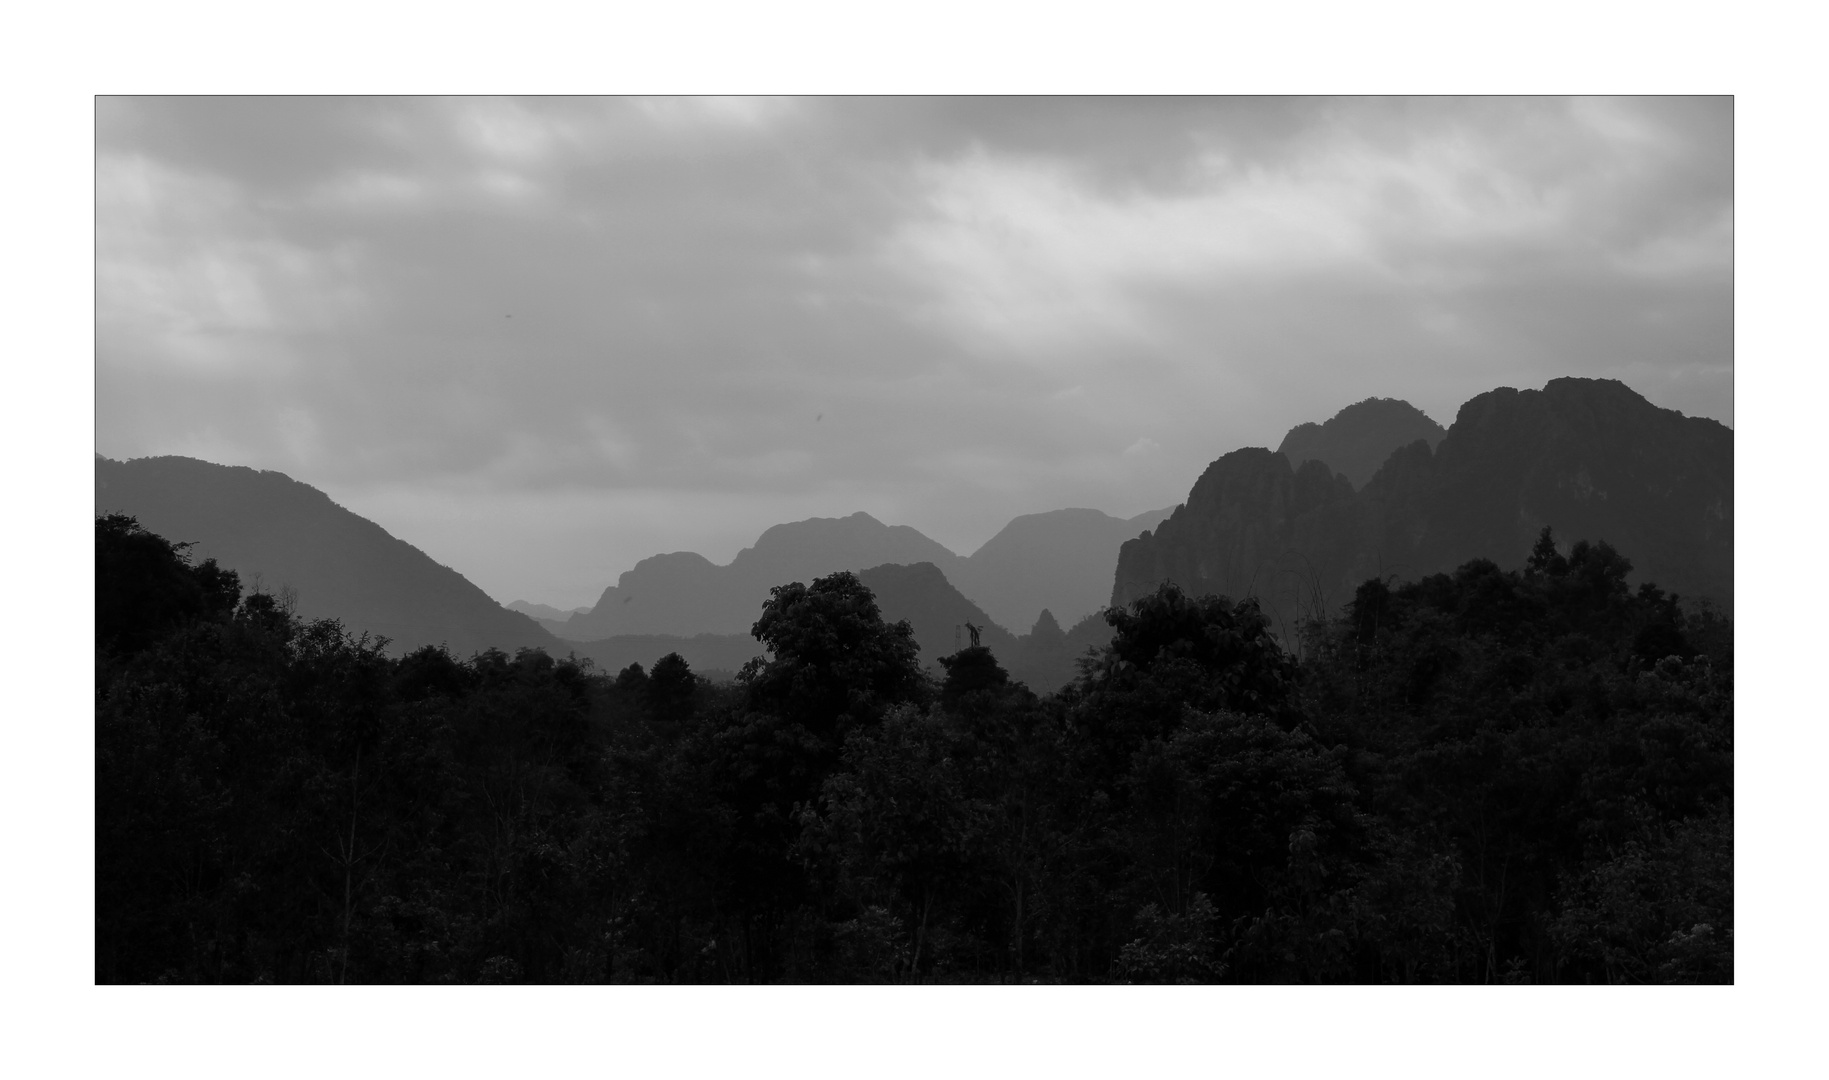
left=95, top=97, right=1734, bottom=608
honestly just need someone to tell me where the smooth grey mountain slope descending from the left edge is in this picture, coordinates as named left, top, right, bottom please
left=95, top=456, right=563, bottom=655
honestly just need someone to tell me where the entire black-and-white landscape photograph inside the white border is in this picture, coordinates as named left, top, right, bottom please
left=95, top=97, right=1734, bottom=983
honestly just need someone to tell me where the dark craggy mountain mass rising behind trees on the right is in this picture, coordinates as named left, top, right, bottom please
left=1112, top=379, right=1734, bottom=632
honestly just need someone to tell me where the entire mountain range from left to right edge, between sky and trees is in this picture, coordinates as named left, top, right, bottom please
left=95, top=379, right=1734, bottom=692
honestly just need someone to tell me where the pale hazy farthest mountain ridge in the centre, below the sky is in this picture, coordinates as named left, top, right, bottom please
left=547, top=509, right=1169, bottom=641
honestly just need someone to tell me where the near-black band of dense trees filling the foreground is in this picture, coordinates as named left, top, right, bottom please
left=95, top=516, right=1734, bottom=983
